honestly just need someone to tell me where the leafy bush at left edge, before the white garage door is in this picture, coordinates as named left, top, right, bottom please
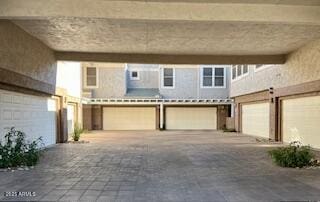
left=0, top=127, right=43, bottom=168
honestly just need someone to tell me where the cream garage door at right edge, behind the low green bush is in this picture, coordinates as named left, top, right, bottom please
left=282, top=96, right=320, bottom=148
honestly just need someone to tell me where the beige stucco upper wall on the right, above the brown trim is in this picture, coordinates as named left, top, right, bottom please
left=230, top=40, right=320, bottom=97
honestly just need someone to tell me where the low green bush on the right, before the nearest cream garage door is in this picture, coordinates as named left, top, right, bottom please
left=269, top=142, right=314, bottom=168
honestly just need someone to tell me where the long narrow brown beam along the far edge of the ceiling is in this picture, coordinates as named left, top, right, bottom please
left=55, top=51, right=286, bottom=64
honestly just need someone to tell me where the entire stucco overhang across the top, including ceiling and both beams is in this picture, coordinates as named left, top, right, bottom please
left=0, top=0, right=320, bottom=64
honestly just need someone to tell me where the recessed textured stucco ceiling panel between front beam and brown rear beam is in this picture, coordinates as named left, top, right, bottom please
left=13, top=18, right=320, bottom=55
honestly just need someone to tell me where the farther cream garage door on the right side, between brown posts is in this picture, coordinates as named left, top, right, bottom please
left=242, top=103, right=270, bottom=138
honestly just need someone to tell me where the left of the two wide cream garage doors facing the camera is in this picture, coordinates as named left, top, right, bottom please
left=103, top=107, right=156, bottom=130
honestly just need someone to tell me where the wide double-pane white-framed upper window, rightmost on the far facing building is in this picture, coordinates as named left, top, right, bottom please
left=201, top=67, right=226, bottom=88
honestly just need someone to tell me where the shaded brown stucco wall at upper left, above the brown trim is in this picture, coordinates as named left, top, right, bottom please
left=0, top=20, right=56, bottom=85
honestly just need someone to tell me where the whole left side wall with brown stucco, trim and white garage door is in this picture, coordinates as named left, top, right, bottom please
left=0, top=20, right=61, bottom=146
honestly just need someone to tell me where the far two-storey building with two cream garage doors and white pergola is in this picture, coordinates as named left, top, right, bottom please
left=82, top=63, right=232, bottom=130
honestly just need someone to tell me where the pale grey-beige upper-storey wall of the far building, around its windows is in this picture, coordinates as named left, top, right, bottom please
left=82, top=63, right=230, bottom=99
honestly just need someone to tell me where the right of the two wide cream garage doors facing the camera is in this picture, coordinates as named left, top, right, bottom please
left=165, top=107, right=217, bottom=130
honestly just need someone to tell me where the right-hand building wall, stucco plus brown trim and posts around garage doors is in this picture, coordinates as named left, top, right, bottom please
left=231, top=40, right=320, bottom=140
